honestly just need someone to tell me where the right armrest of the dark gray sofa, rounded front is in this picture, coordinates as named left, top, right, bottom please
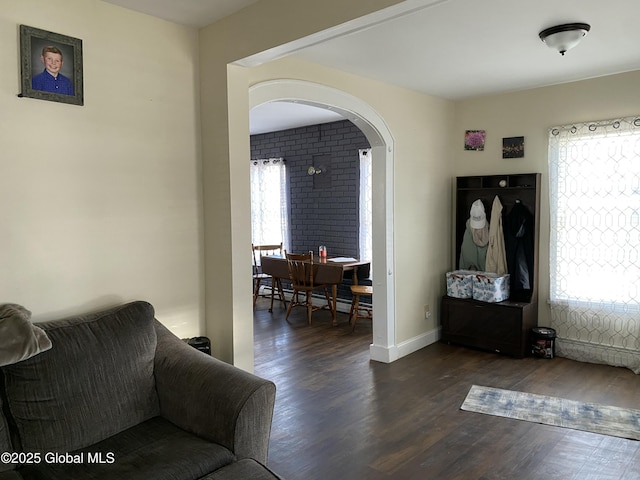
left=155, top=320, right=276, bottom=465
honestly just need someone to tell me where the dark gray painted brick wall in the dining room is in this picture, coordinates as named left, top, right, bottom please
left=251, top=120, right=370, bottom=298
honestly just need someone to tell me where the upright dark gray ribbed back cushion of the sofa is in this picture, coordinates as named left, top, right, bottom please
left=2, top=302, right=159, bottom=452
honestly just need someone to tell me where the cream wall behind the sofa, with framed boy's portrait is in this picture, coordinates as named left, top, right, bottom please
left=0, top=0, right=204, bottom=337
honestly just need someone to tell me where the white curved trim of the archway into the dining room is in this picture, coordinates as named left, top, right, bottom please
left=249, top=79, right=400, bottom=363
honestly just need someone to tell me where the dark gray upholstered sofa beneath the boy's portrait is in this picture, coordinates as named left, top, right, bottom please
left=0, top=301, right=279, bottom=480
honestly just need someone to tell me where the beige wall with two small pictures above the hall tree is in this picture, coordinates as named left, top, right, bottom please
left=451, top=71, right=640, bottom=325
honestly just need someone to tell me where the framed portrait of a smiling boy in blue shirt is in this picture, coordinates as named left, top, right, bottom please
left=19, top=25, right=84, bottom=105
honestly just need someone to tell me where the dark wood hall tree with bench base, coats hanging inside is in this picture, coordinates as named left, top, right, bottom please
left=440, top=173, right=540, bottom=357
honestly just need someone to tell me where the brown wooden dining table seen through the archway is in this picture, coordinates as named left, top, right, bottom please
left=260, top=255, right=371, bottom=326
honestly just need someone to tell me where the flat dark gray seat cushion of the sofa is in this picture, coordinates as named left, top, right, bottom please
left=19, top=417, right=235, bottom=480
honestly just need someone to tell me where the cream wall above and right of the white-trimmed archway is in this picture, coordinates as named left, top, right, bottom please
left=250, top=59, right=453, bottom=344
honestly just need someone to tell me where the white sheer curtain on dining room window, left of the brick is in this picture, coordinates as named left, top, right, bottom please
left=250, top=158, right=289, bottom=249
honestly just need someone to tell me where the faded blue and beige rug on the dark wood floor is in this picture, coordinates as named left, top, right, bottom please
left=460, top=385, right=640, bottom=440
